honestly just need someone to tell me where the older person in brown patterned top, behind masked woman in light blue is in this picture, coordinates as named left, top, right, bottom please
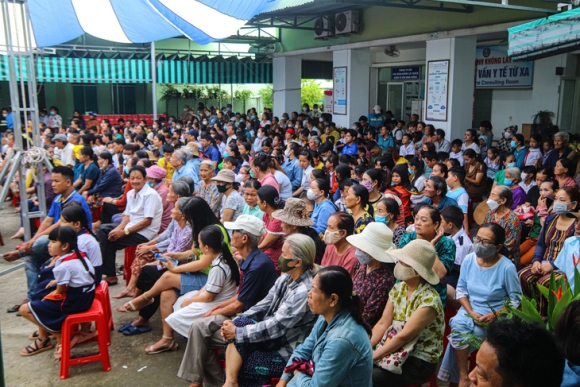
left=483, top=185, right=521, bottom=268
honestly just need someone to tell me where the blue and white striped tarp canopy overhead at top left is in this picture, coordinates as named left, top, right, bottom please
left=28, top=0, right=284, bottom=47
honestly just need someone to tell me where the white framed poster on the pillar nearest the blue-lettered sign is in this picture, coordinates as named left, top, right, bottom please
left=425, top=59, right=449, bottom=121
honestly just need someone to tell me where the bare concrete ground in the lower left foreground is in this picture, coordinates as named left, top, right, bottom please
left=0, top=203, right=189, bottom=387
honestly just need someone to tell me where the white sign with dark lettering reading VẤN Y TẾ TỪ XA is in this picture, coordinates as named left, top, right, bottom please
left=475, top=46, right=534, bottom=89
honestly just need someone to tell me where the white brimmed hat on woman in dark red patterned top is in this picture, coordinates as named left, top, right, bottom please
left=346, top=222, right=397, bottom=263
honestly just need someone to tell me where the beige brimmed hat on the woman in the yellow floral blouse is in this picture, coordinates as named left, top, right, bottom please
left=388, top=239, right=439, bottom=285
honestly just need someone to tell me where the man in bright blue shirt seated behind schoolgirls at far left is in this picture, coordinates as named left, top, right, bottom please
left=3, top=167, right=93, bottom=304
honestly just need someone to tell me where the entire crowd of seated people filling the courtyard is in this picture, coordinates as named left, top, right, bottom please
left=3, top=104, right=580, bottom=387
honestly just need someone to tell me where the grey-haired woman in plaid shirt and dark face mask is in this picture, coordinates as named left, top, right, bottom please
left=222, top=234, right=317, bottom=387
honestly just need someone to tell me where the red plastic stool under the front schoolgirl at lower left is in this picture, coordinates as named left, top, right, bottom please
left=60, top=299, right=111, bottom=379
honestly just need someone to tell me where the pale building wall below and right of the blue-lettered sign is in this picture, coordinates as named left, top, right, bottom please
left=491, top=54, right=566, bottom=133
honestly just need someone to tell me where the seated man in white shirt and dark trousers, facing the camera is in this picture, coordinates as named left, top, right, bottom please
left=97, top=166, right=163, bottom=285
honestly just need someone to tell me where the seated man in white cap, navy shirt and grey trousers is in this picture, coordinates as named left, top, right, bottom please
left=177, top=215, right=278, bottom=386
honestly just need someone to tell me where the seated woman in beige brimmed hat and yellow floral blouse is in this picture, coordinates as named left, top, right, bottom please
left=371, top=239, right=445, bottom=387
